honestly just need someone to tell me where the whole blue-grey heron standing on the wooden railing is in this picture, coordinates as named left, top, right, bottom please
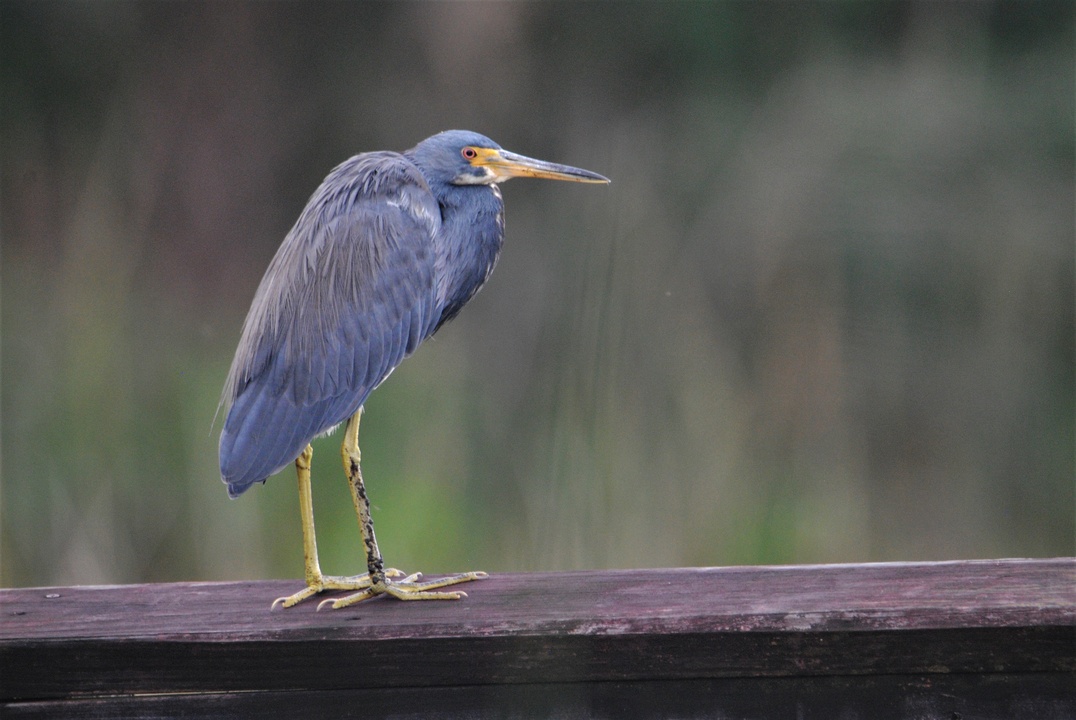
left=218, top=130, right=609, bottom=609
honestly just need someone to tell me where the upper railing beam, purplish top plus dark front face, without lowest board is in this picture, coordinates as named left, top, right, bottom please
left=0, top=559, right=1076, bottom=710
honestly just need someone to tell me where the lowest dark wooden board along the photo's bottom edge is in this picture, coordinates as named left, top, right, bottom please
left=4, top=673, right=1076, bottom=720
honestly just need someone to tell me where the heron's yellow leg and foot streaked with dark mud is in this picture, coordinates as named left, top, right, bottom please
left=311, top=408, right=486, bottom=609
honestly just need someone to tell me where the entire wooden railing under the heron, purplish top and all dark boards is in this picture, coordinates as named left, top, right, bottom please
left=0, top=559, right=1076, bottom=720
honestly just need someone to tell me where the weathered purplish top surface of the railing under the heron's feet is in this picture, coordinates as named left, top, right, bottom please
left=0, top=559, right=1076, bottom=641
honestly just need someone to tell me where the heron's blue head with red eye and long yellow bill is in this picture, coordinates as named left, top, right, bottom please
left=407, top=130, right=609, bottom=185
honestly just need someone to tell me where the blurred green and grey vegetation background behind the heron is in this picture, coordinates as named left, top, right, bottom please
left=0, top=0, right=1076, bottom=585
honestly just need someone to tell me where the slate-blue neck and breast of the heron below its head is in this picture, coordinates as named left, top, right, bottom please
left=435, top=185, right=505, bottom=326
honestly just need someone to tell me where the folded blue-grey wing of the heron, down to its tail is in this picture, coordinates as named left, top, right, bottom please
left=221, top=153, right=441, bottom=495
